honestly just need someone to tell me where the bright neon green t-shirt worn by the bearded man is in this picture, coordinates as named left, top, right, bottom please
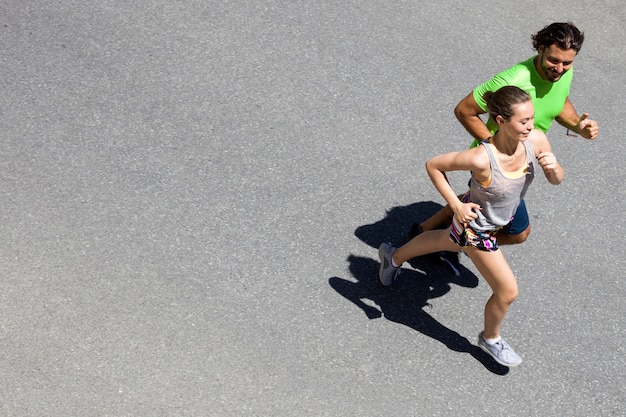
left=474, top=57, right=574, bottom=143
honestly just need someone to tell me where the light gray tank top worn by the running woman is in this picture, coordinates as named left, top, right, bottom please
left=469, top=138, right=536, bottom=232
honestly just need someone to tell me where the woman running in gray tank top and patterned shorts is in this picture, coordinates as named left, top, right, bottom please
left=378, top=86, right=564, bottom=366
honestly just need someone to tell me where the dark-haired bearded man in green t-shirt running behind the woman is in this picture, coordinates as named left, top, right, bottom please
left=409, top=22, right=598, bottom=245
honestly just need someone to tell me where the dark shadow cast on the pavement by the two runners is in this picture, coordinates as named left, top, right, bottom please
left=328, top=202, right=509, bottom=375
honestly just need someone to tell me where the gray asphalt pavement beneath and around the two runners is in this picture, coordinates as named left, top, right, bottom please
left=0, top=0, right=626, bottom=416
